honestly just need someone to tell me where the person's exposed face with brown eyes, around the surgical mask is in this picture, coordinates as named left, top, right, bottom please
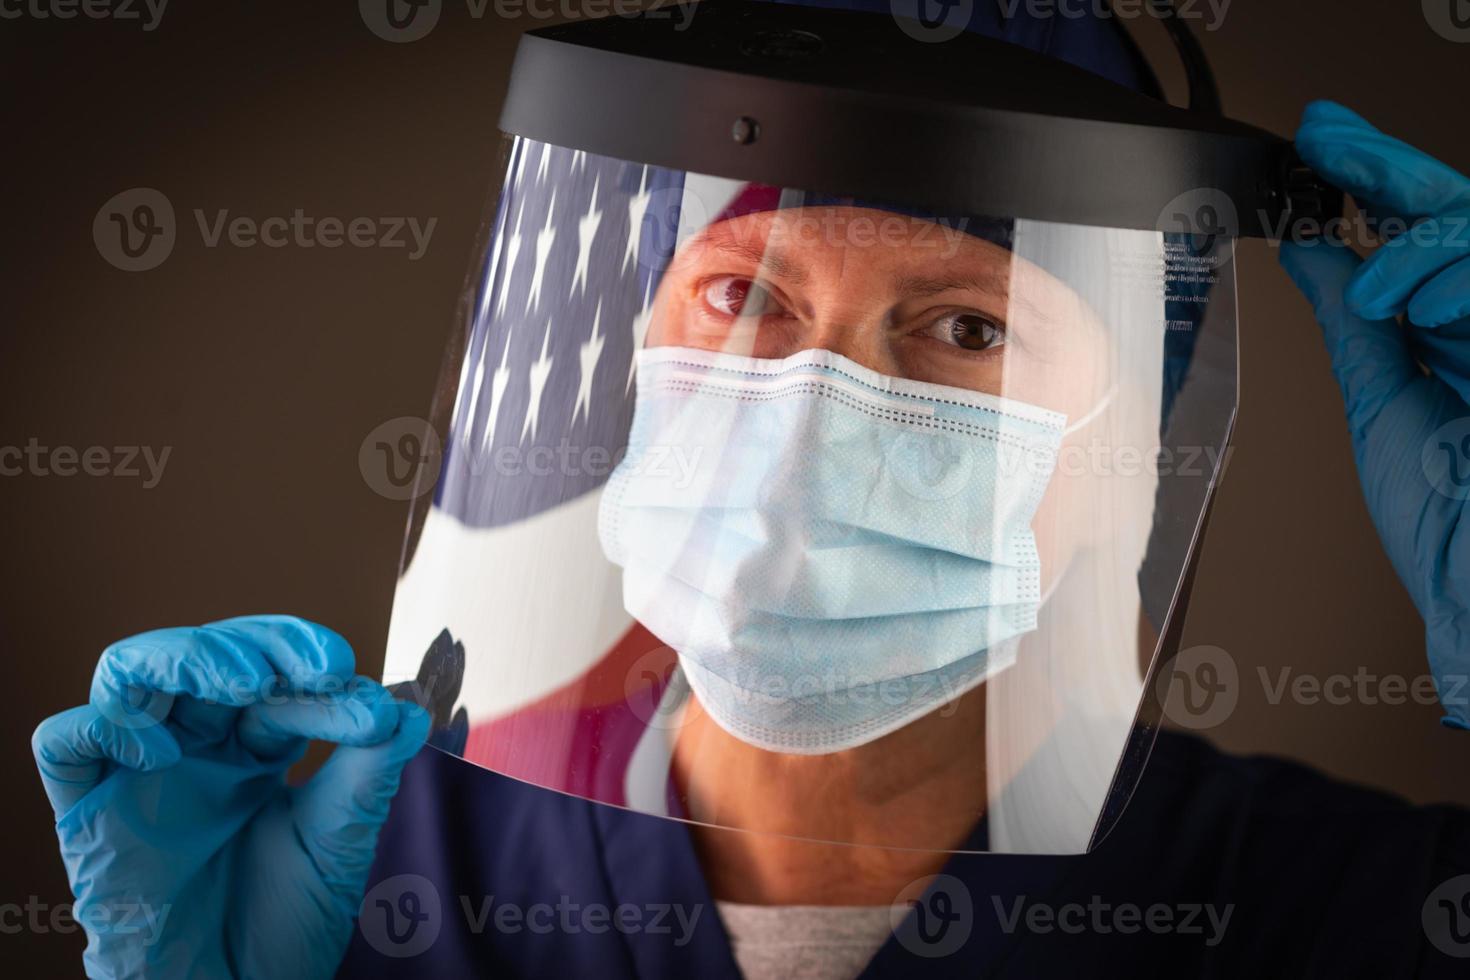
left=647, top=207, right=1108, bottom=588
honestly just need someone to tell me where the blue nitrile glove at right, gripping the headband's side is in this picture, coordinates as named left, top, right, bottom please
left=1280, top=101, right=1470, bottom=729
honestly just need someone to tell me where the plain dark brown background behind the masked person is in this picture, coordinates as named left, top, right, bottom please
left=0, top=0, right=1470, bottom=974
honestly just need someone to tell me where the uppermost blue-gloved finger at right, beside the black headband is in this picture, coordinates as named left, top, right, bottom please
left=1297, top=101, right=1470, bottom=219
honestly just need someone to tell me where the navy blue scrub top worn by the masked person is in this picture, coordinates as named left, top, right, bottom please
left=340, top=732, right=1470, bottom=980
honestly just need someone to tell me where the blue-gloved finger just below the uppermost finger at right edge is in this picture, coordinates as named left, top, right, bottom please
left=1347, top=209, right=1470, bottom=326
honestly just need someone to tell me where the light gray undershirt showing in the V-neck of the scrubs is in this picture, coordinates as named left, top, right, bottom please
left=716, top=902, right=908, bottom=980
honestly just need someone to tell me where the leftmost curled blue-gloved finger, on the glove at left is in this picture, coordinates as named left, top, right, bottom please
left=31, top=704, right=181, bottom=820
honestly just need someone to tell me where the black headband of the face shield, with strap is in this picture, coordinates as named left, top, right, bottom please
left=501, top=0, right=1342, bottom=238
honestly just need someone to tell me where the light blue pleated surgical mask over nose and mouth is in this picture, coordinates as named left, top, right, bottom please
left=598, top=347, right=1070, bottom=754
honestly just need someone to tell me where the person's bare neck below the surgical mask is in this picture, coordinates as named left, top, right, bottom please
left=673, top=688, right=985, bottom=905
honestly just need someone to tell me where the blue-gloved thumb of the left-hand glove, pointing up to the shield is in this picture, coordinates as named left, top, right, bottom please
left=293, top=701, right=429, bottom=904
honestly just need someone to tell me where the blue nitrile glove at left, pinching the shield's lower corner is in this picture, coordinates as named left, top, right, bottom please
left=32, top=616, right=428, bottom=979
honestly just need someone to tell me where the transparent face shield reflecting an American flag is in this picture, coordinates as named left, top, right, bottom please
left=385, top=4, right=1334, bottom=854
